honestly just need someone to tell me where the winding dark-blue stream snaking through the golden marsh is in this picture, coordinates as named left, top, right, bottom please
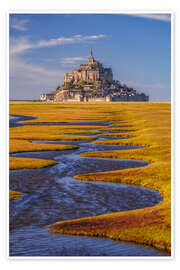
left=9, top=115, right=165, bottom=257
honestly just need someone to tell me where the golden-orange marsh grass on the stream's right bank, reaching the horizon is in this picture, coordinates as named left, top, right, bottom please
left=10, top=102, right=171, bottom=252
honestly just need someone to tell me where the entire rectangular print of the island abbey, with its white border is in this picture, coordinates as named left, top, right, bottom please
left=9, top=14, right=174, bottom=258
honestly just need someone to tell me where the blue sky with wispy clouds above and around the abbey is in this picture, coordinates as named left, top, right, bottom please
left=9, top=14, right=171, bottom=101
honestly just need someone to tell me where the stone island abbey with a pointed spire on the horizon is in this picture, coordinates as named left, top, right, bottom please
left=40, top=49, right=149, bottom=102
